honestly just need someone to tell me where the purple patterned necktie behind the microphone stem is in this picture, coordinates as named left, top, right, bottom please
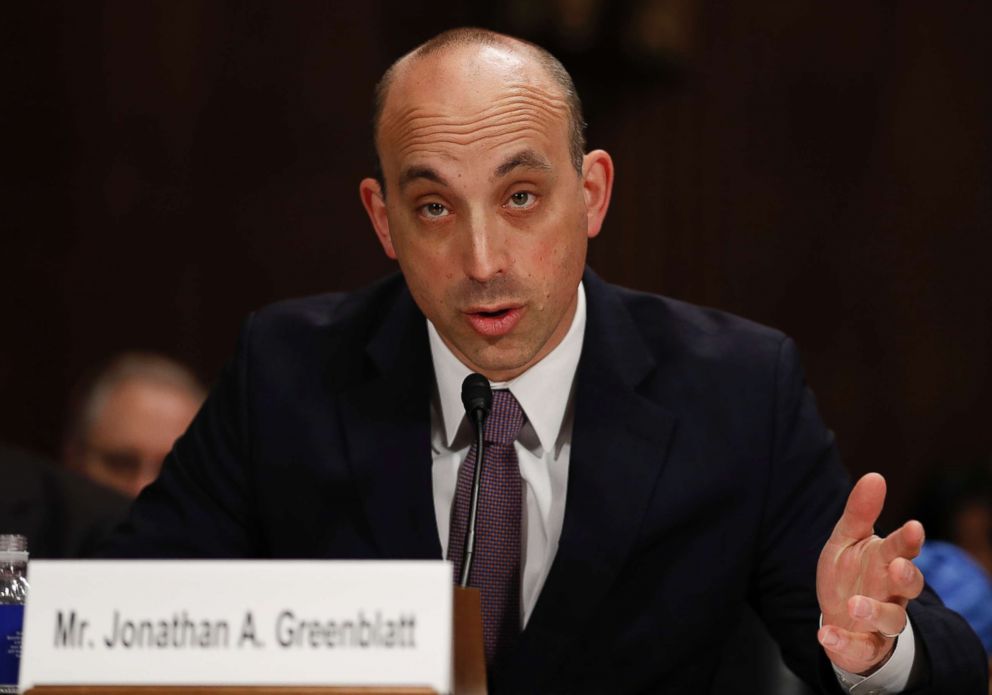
left=448, top=390, right=524, bottom=668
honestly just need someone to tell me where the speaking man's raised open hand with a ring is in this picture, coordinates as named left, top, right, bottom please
left=816, top=473, right=923, bottom=674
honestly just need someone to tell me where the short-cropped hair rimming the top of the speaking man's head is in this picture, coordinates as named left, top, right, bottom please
left=372, top=27, right=586, bottom=189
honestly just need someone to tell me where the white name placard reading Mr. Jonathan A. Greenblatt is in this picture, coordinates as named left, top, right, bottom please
left=20, top=560, right=452, bottom=693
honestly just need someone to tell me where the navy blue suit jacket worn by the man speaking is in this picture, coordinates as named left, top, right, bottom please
left=109, top=272, right=985, bottom=694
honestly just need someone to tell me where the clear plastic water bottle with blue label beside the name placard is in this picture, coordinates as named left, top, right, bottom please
left=0, top=535, right=28, bottom=693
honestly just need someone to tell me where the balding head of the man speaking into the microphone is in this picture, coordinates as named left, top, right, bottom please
left=359, top=29, right=613, bottom=381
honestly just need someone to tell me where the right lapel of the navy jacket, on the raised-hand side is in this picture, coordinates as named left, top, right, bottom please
left=505, top=271, right=675, bottom=691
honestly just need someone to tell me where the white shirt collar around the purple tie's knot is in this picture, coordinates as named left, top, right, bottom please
left=427, top=282, right=586, bottom=451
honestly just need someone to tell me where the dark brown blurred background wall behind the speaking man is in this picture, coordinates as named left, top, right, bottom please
left=0, top=0, right=992, bottom=521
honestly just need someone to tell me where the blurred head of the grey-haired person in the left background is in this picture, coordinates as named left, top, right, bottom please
left=64, top=352, right=206, bottom=497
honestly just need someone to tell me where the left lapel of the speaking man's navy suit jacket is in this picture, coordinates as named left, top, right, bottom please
left=339, top=286, right=441, bottom=560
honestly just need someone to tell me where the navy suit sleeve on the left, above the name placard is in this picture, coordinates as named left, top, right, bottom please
left=99, top=317, right=264, bottom=558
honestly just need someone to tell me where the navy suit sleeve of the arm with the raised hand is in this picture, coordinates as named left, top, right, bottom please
left=750, top=338, right=988, bottom=695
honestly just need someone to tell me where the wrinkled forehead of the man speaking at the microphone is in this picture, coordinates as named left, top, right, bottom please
left=378, top=46, right=568, bottom=171
